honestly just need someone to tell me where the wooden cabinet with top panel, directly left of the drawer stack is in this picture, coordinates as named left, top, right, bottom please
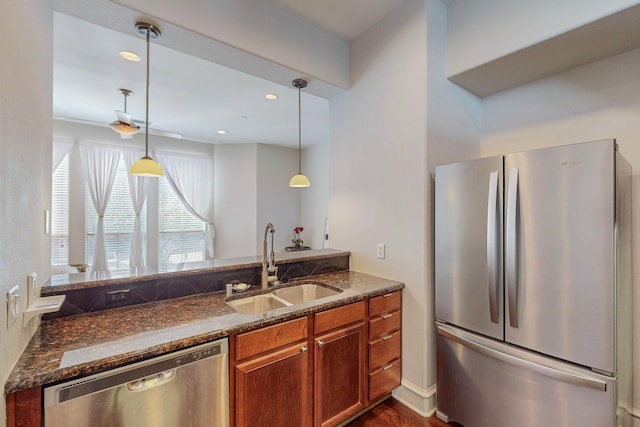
left=313, top=301, right=366, bottom=426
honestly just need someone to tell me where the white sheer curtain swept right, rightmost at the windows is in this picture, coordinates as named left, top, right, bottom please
left=154, top=151, right=216, bottom=259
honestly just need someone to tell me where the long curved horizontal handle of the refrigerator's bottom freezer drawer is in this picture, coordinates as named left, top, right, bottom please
left=436, top=323, right=607, bottom=392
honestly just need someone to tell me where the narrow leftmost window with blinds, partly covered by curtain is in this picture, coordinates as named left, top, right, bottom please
left=51, top=154, right=69, bottom=265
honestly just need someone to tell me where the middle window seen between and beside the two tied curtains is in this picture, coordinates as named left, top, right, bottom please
left=85, top=157, right=147, bottom=271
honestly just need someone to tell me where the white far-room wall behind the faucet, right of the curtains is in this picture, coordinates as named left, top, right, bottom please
left=215, top=144, right=312, bottom=258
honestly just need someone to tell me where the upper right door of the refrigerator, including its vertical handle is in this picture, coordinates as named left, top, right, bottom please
left=505, top=140, right=615, bottom=372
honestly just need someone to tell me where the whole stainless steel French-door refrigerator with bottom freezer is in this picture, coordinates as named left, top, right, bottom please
left=435, top=140, right=632, bottom=427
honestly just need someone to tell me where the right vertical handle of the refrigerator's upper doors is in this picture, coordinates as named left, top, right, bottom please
left=505, top=168, right=519, bottom=328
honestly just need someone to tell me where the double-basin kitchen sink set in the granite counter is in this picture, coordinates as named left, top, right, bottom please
left=227, top=283, right=342, bottom=314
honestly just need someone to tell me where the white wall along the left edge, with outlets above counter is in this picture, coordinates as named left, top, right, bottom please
left=0, top=0, right=53, bottom=425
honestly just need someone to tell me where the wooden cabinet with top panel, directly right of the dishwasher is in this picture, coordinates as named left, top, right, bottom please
left=231, top=317, right=311, bottom=427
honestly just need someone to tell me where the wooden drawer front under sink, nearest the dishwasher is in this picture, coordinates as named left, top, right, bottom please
left=236, top=317, right=307, bottom=360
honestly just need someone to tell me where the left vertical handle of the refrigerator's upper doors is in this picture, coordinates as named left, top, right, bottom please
left=487, top=171, right=499, bottom=323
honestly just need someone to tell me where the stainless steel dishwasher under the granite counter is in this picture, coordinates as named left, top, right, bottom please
left=44, top=338, right=229, bottom=427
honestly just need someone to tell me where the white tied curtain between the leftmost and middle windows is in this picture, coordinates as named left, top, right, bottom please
left=79, top=142, right=122, bottom=271
